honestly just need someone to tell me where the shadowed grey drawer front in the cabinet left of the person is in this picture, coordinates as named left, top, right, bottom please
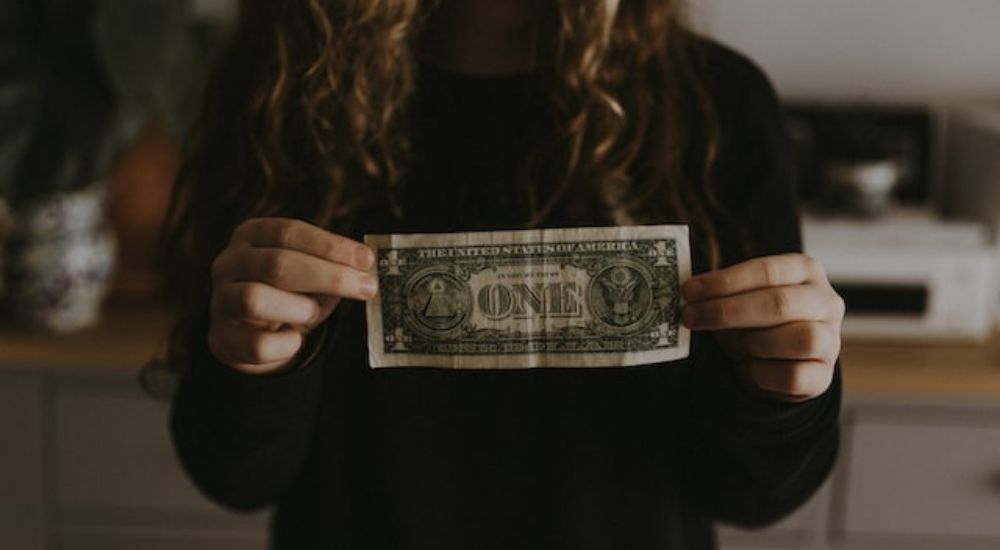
left=52, top=380, right=265, bottom=531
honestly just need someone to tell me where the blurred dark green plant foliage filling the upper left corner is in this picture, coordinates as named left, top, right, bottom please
left=0, top=0, right=226, bottom=207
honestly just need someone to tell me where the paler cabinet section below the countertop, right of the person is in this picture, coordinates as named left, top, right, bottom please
left=720, top=399, right=1000, bottom=550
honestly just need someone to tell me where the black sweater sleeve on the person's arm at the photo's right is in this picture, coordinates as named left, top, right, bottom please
left=684, top=44, right=841, bottom=527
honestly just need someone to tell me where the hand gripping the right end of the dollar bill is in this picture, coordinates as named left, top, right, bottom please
left=683, top=254, right=844, bottom=402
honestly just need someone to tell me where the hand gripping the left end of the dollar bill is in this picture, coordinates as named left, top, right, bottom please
left=208, top=218, right=378, bottom=374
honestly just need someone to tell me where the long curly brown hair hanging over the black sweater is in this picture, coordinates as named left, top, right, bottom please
left=156, top=0, right=732, bottom=386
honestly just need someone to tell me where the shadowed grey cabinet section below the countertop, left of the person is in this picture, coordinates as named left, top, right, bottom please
left=0, top=369, right=267, bottom=550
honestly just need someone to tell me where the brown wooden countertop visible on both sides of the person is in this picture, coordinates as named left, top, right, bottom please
left=0, top=306, right=1000, bottom=400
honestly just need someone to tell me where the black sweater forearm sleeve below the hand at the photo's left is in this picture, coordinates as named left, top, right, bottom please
left=170, top=315, right=330, bottom=511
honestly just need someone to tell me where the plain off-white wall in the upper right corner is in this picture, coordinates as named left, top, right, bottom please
left=690, top=0, right=1000, bottom=104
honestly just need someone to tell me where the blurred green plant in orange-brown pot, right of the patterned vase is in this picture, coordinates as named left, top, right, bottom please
left=94, top=0, right=235, bottom=302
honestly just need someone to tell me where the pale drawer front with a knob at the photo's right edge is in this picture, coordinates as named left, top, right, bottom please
left=842, top=414, right=1000, bottom=547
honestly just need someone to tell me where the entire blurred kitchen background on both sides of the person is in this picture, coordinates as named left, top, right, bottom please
left=0, top=0, right=1000, bottom=550
